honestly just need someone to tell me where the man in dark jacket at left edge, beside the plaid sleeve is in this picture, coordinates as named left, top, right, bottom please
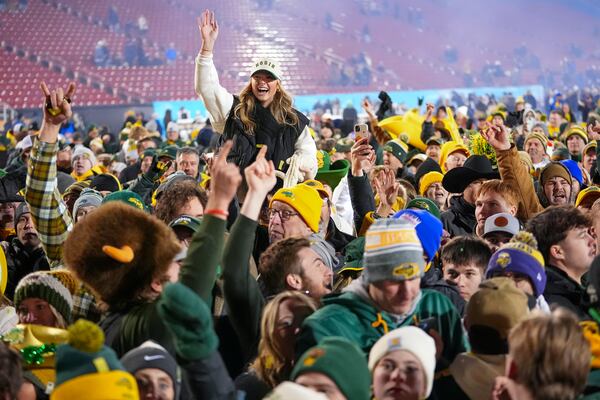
left=0, top=202, right=50, bottom=300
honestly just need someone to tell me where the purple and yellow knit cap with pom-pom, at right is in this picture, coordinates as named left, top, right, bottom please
left=485, top=231, right=546, bottom=297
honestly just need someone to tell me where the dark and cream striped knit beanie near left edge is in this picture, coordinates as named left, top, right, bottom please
left=14, top=269, right=77, bottom=323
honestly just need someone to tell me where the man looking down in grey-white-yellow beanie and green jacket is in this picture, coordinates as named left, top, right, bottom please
left=296, top=218, right=465, bottom=370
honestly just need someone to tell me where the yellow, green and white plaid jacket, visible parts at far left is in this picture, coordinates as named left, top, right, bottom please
left=25, top=139, right=100, bottom=321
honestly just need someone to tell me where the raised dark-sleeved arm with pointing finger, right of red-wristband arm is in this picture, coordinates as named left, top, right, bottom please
left=223, top=146, right=276, bottom=356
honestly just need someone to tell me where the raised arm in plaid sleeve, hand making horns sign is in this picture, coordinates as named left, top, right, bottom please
left=25, top=82, right=75, bottom=265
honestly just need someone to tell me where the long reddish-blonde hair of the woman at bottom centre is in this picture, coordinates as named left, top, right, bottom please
left=250, top=291, right=317, bottom=387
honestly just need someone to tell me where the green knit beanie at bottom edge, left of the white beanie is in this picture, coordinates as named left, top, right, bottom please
left=290, top=337, right=371, bottom=400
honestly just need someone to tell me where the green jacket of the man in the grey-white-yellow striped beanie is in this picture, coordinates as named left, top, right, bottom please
left=296, top=281, right=468, bottom=371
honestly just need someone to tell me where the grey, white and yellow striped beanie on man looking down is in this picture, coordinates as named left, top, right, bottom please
left=364, top=218, right=425, bottom=283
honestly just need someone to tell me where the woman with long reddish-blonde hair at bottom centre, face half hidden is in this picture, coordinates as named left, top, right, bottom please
left=235, top=291, right=317, bottom=400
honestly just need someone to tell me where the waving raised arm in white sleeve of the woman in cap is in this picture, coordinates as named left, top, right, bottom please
left=194, top=10, right=233, bottom=133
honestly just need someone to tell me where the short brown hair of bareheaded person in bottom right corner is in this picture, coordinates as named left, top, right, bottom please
left=508, top=309, right=591, bottom=400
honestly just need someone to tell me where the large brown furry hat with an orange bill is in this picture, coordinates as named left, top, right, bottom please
left=63, top=202, right=180, bottom=310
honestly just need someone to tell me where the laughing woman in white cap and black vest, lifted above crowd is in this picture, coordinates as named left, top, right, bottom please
left=195, top=10, right=317, bottom=193
